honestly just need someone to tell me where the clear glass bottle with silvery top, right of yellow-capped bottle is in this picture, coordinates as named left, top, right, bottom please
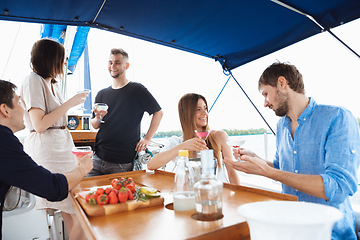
left=194, top=150, right=223, bottom=221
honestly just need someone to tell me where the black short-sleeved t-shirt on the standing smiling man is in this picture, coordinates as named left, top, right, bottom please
left=95, top=82, right=161, bottom=164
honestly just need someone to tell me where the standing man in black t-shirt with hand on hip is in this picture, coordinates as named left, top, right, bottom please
left=87, top=49, right=163, bottom=177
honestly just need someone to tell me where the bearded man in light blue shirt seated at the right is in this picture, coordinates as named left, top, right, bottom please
left=224, top=63, right=360, bottom=240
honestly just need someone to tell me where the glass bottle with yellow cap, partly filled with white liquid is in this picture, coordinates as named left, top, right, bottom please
left=173, top=150, right=195, bottom=211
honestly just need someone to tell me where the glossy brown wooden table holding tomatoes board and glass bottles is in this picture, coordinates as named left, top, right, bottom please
left=71, top=170, right=297, bottom=240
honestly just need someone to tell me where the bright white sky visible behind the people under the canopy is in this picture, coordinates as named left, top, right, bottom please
left=0, top=19, right=360, bottom=132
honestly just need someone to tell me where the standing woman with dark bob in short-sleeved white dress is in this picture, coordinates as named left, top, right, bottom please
left=20, top=39, right=88, bottom=240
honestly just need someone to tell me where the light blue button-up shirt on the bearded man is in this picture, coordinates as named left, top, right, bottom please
left=273, top=98, right=360, bottom=240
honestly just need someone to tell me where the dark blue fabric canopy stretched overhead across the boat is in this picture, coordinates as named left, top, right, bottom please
left=0, top=0, right=360, bottom=69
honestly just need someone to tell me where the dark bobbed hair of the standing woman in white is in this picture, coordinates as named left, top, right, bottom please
left=31, top=38, right=65, bottom=83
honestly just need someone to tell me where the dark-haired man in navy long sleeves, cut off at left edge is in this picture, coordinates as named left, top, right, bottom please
left=0, top=80, right=93, bottom=239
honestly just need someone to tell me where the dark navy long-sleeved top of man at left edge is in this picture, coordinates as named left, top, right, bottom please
left=0, top=125, right=68, bottom=239
